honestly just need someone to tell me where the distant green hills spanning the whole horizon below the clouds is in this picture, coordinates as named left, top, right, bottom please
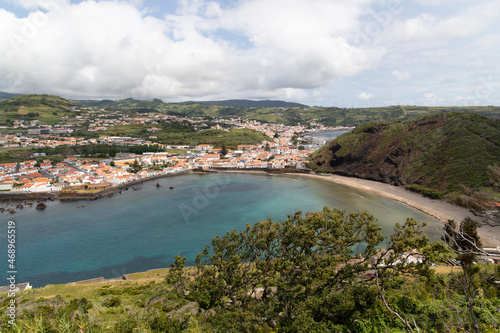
left=0, top=92, right=500, bottom=127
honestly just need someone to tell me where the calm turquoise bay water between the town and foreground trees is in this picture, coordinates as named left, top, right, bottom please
left=0, top=173, right=441, bottom=287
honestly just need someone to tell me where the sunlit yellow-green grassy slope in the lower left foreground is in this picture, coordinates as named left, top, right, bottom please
left=0, top=270, right=192, bottom=332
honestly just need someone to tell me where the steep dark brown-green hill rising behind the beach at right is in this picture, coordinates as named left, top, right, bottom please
left=310, top=112, right=500, bottom=192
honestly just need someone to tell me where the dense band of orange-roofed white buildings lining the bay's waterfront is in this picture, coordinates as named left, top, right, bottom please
left=0, top=138, right=312, bottom=192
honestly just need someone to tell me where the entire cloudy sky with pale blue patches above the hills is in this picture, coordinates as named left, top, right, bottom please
left=0, top=0, right=500, bottom=107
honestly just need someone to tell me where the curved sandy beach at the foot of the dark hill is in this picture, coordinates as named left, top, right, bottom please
left=289, top=173, right=500, bottom=247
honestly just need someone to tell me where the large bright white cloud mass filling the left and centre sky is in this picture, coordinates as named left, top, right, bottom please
left=0, top=0, right=384, bottom=100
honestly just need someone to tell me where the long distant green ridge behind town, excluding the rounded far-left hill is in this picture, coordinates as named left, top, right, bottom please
left=74, top=98, right=500, bottom=126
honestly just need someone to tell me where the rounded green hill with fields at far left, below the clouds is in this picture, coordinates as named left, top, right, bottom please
left=0, top=95, right=77, bottom=125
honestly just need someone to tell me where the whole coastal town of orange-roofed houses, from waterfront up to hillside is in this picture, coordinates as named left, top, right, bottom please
left=0, top=108, right=350, bottom=193
